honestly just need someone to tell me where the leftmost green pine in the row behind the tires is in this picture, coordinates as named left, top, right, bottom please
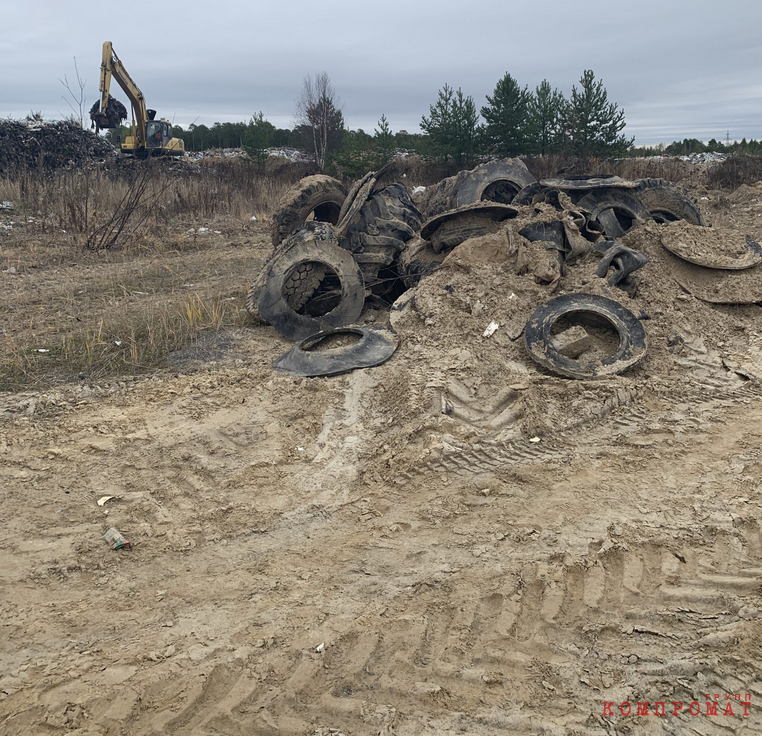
left=421, top=84, right=479, bottom=173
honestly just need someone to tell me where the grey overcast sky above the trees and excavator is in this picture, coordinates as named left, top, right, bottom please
left=0, top=0, right=762, bottom=145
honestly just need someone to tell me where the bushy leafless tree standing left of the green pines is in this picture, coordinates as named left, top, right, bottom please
left=296, top=72, right=344, bottom=171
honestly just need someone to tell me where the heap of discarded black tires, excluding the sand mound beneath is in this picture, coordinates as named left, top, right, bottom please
left=247, top=159, right=762, bottom=379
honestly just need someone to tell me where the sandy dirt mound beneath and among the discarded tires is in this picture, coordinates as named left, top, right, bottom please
left=360, top=208, right=762, bottom=454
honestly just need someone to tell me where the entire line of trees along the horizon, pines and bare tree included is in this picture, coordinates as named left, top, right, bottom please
left=102, top=69, right=762, bottom=177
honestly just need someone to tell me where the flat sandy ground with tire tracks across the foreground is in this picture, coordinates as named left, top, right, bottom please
left=0, top=185, right=762, bottom=736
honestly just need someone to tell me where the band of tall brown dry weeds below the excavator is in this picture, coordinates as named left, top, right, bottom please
left=0, top=159, right=303, bottom=250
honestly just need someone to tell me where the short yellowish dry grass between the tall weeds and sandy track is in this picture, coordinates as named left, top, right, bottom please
left=0, top=237, right=264, bottom=391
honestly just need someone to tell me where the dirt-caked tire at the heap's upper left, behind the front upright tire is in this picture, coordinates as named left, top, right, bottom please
left=271, top=174, right=347, bottom=248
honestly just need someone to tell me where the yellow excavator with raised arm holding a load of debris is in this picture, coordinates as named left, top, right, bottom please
left=90, top=41, right=185, bottom=158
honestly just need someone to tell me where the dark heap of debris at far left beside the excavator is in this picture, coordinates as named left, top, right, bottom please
left=0, top=118, right=116, bottom=174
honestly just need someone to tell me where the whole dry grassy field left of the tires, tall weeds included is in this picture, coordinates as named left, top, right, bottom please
left=0, top=161, right=298, bottom=391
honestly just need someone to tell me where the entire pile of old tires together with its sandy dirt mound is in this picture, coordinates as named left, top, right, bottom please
left=247, top=161, right=762, bottom=441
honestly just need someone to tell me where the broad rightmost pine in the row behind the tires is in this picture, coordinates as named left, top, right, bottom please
left=564, top=69, right=635, bottom=157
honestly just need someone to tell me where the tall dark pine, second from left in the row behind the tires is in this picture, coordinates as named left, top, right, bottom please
left=482, top=72, right=532, bottom=156
